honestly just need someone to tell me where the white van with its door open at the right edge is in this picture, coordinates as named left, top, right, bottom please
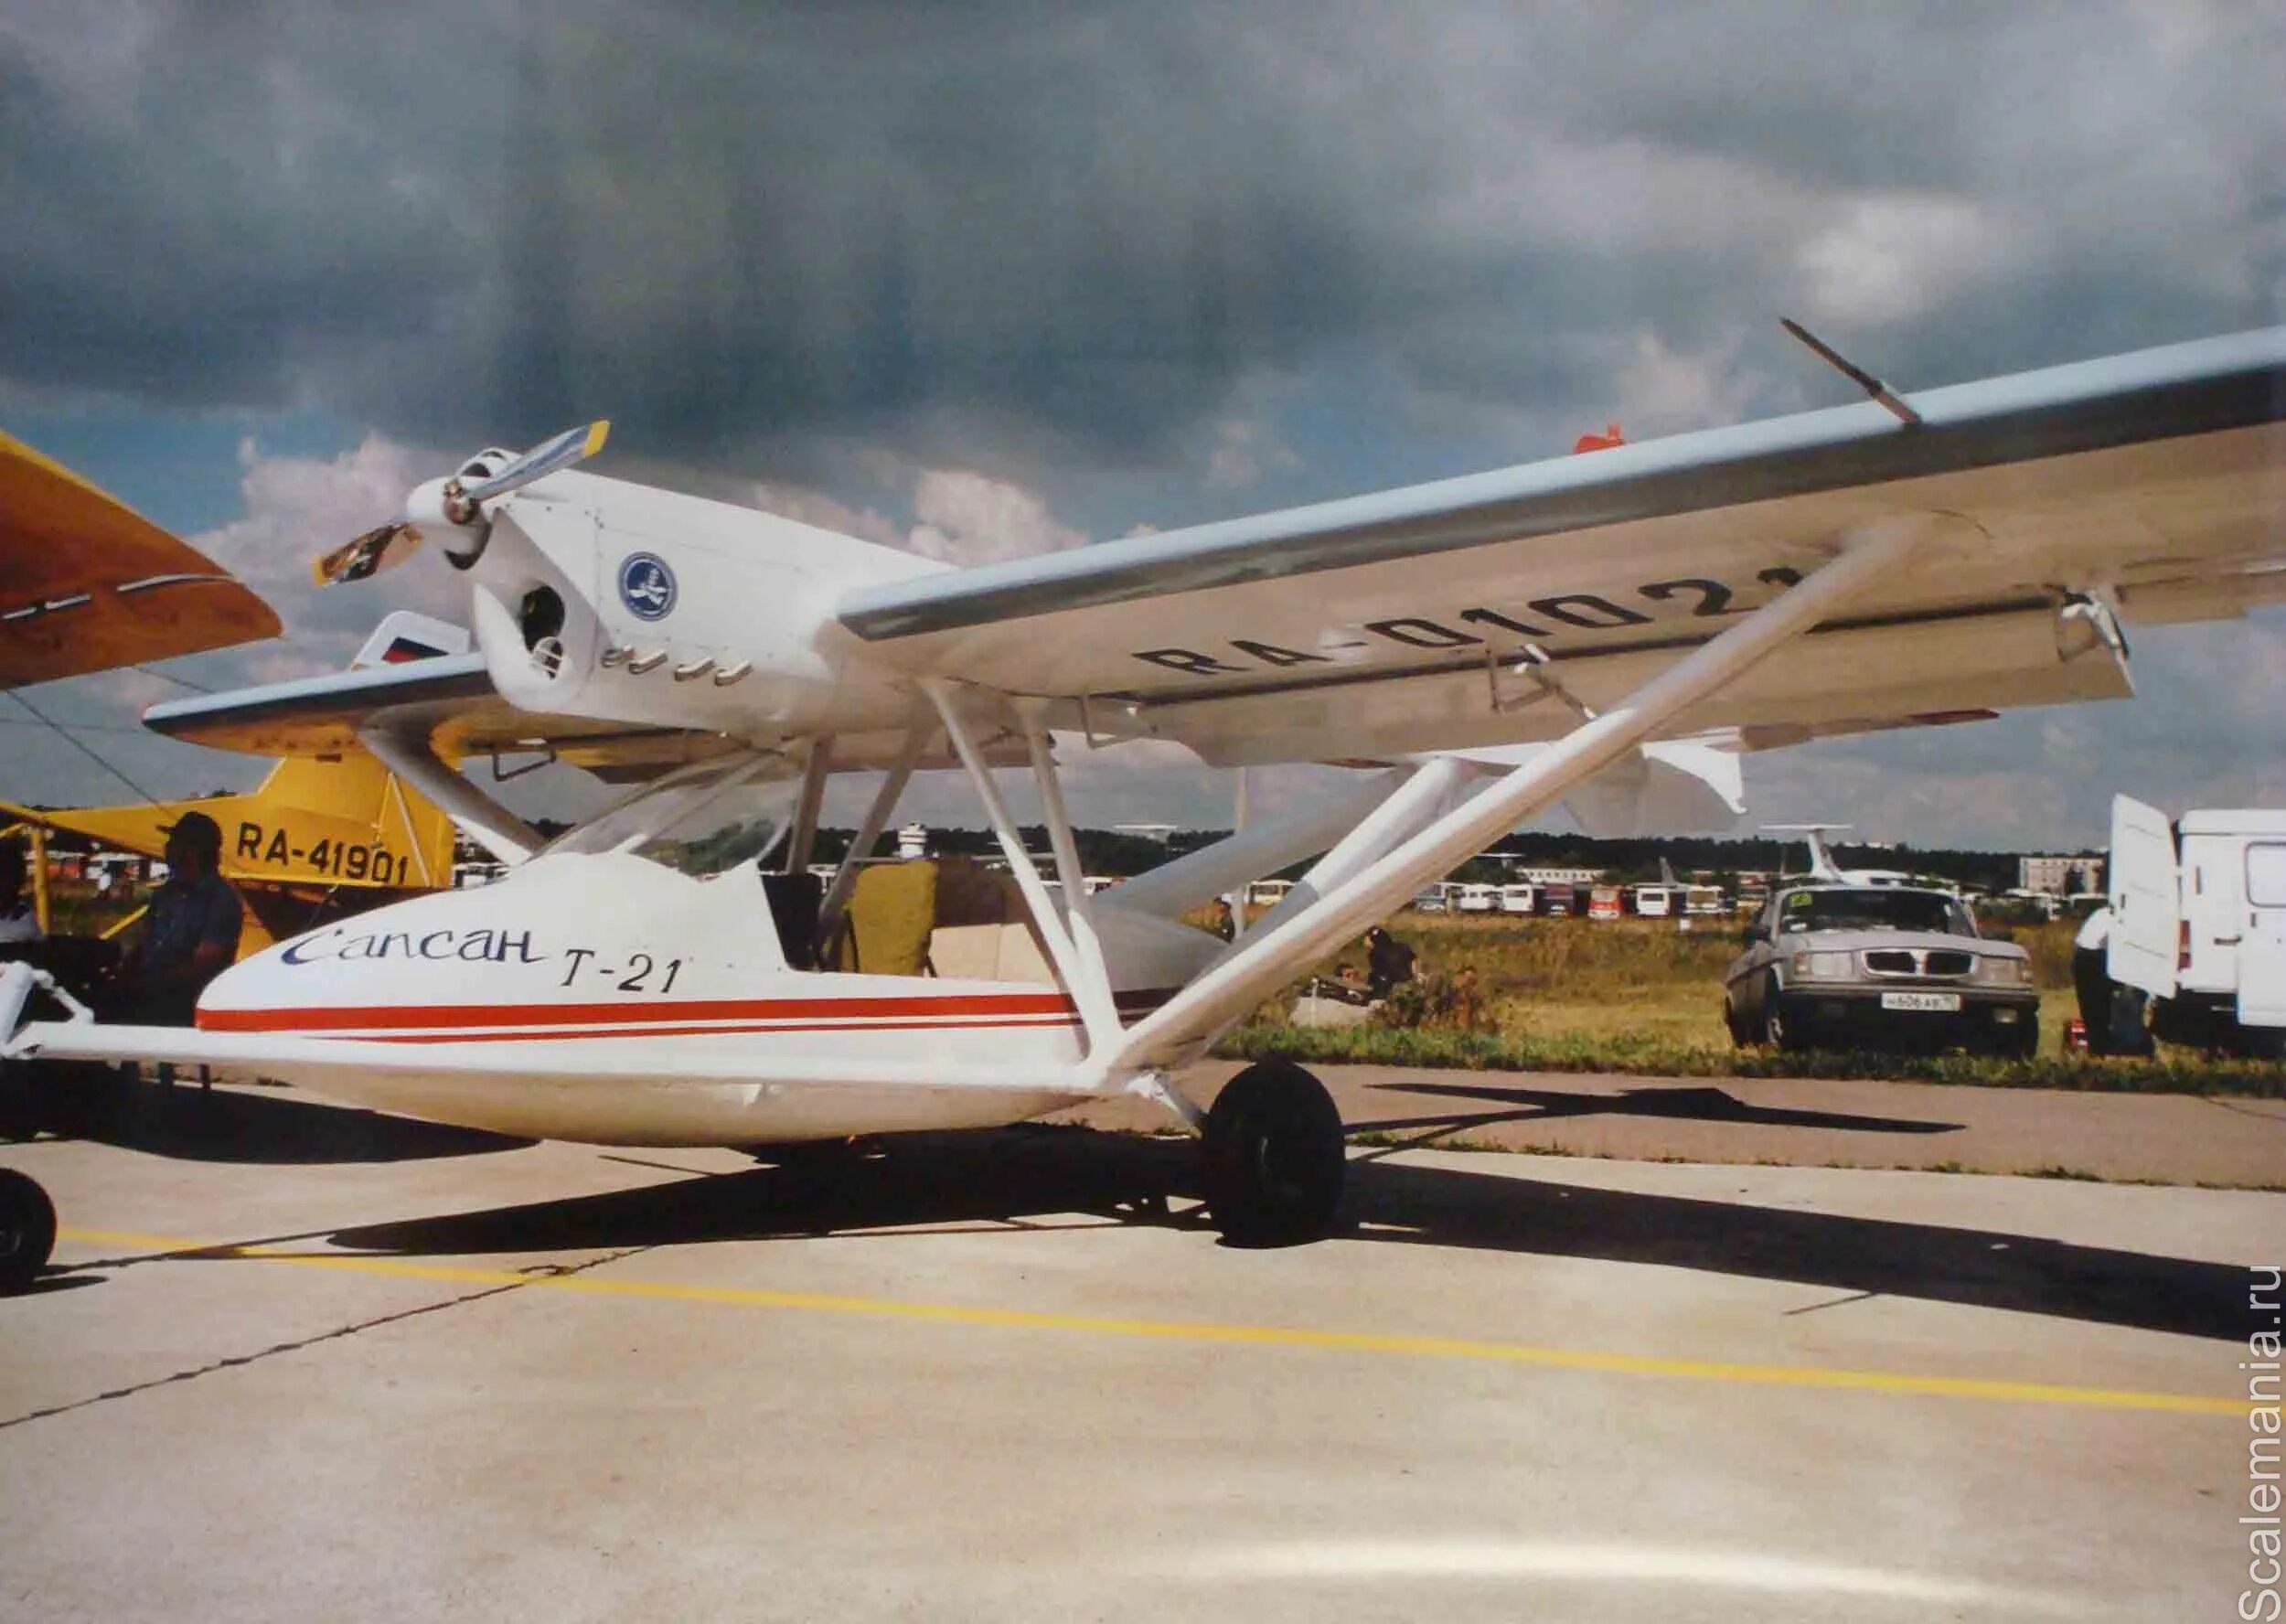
left=2106, top=796, right=2286, bottom=1054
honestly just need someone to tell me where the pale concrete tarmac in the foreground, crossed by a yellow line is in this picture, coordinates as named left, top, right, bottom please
left=0, top=1080, right=2286, bottom=1624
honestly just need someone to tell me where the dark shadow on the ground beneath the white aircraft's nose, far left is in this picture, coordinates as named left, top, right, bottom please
left=22, top=1066, right=533, bottom=1167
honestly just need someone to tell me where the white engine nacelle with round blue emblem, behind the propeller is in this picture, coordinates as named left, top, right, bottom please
left=459, top=474, right=942, bottom=739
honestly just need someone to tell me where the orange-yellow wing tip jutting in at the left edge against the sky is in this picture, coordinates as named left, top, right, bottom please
left=0, top=434, right=279, bottom=689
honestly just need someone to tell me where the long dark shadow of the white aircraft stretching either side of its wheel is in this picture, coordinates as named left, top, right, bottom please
left=294, top=1127, right=2245, bottom=1338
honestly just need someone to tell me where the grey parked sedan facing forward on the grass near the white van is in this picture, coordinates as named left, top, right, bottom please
left=1724, top=883, right=2039, bottom=1054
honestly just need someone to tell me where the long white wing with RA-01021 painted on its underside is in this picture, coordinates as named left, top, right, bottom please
left=839, top=327, right=2286, bottom=762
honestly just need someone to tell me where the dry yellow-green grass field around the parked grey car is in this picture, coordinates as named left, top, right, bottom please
left=1216, top=913, right=2286, bottom=1098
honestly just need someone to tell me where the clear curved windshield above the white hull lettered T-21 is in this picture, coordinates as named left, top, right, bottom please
left=544, top=750, right=803, bottom=876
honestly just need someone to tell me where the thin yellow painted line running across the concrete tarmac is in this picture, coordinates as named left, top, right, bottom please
left=58, top=1228, right=2249, bottom=1416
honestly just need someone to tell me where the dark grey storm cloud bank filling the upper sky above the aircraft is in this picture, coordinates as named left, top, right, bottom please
left=0, top=5, right=2286, bottom=466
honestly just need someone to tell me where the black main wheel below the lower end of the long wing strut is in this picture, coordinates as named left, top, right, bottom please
left=1201, top=1062, right=1349, bottom=1246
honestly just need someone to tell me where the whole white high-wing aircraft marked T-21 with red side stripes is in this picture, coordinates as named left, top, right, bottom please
left=0, top=327, right=2286, bottom=1242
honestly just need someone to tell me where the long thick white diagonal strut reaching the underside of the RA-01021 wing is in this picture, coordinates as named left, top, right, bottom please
left=1102, top=515, right=1961, bottom=1082
